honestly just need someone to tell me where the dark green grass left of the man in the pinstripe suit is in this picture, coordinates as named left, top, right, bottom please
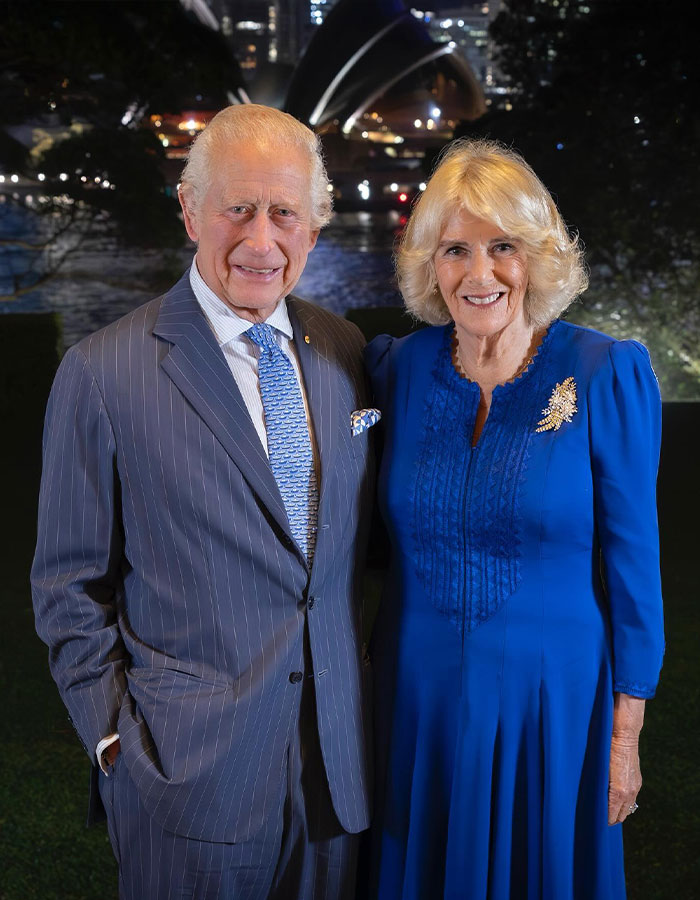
left=0, top=452, right=117, bottom=900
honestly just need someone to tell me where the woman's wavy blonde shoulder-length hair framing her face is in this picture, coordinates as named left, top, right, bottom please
left=396, top=139, right=588, bottom=327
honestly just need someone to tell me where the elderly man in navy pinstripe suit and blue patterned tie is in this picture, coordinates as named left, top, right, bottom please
left=32, top=105, right=373, bottom=900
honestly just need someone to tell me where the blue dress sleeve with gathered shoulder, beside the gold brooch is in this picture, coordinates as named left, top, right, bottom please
left=589, top=341, right=664, bottom=697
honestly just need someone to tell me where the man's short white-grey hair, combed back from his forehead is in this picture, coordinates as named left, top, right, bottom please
left=180, top=103, right=333, bottom=230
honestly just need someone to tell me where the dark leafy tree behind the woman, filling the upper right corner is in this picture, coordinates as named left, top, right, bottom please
left=464, top=0, right=700, bottom=395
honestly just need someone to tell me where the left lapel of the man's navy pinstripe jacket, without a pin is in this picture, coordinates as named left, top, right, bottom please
left=153, top=272, right=291, bottom=536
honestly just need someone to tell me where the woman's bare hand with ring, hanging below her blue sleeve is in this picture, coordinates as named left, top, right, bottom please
left=608, top=694, right=645, bottom=825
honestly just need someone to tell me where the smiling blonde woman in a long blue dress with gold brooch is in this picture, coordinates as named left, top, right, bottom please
left=367, top=141, right=663, bottom=900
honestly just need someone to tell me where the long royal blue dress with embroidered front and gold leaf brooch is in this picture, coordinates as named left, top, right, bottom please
left=367, top=321, right=663, bottom=900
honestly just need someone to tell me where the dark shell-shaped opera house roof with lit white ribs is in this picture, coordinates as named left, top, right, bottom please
left=285, top=0, right=485, bottom=136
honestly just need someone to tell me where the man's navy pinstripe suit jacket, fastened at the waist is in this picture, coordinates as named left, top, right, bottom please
left=32, top=274, right=374, bottom=841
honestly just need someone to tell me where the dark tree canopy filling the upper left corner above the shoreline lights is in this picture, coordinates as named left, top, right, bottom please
left=0, top=0, right=240, bottom=127
